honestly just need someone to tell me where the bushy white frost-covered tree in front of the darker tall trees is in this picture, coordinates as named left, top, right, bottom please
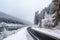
left=42, top=12, right=55, bottom=28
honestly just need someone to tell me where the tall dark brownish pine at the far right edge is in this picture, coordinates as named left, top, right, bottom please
left=52, top=0, right=60, bottom=27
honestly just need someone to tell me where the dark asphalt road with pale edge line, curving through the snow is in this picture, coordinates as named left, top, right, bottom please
left=27, top=27, right=60, bottom=40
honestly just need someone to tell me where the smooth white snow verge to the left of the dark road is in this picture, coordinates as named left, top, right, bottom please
left=3, top=27, right=33, bottom=40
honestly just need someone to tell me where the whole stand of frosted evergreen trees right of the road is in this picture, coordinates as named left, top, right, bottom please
left=34, top=0, right=60, bottom=29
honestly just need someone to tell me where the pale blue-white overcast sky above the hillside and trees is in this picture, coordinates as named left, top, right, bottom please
left=0, top=0, right=51, bottom=22
